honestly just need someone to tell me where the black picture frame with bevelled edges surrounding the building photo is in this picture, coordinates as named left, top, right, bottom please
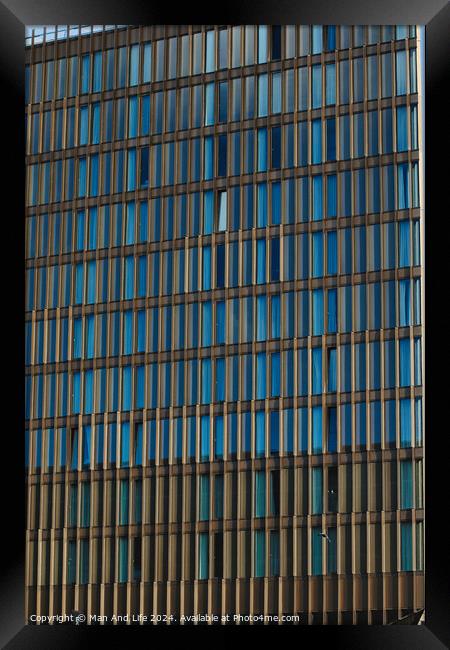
left=0, top=0, right=450, bottom=650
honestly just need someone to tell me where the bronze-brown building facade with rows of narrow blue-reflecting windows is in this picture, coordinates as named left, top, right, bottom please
left=25, top=25, right=424, bottom=624
